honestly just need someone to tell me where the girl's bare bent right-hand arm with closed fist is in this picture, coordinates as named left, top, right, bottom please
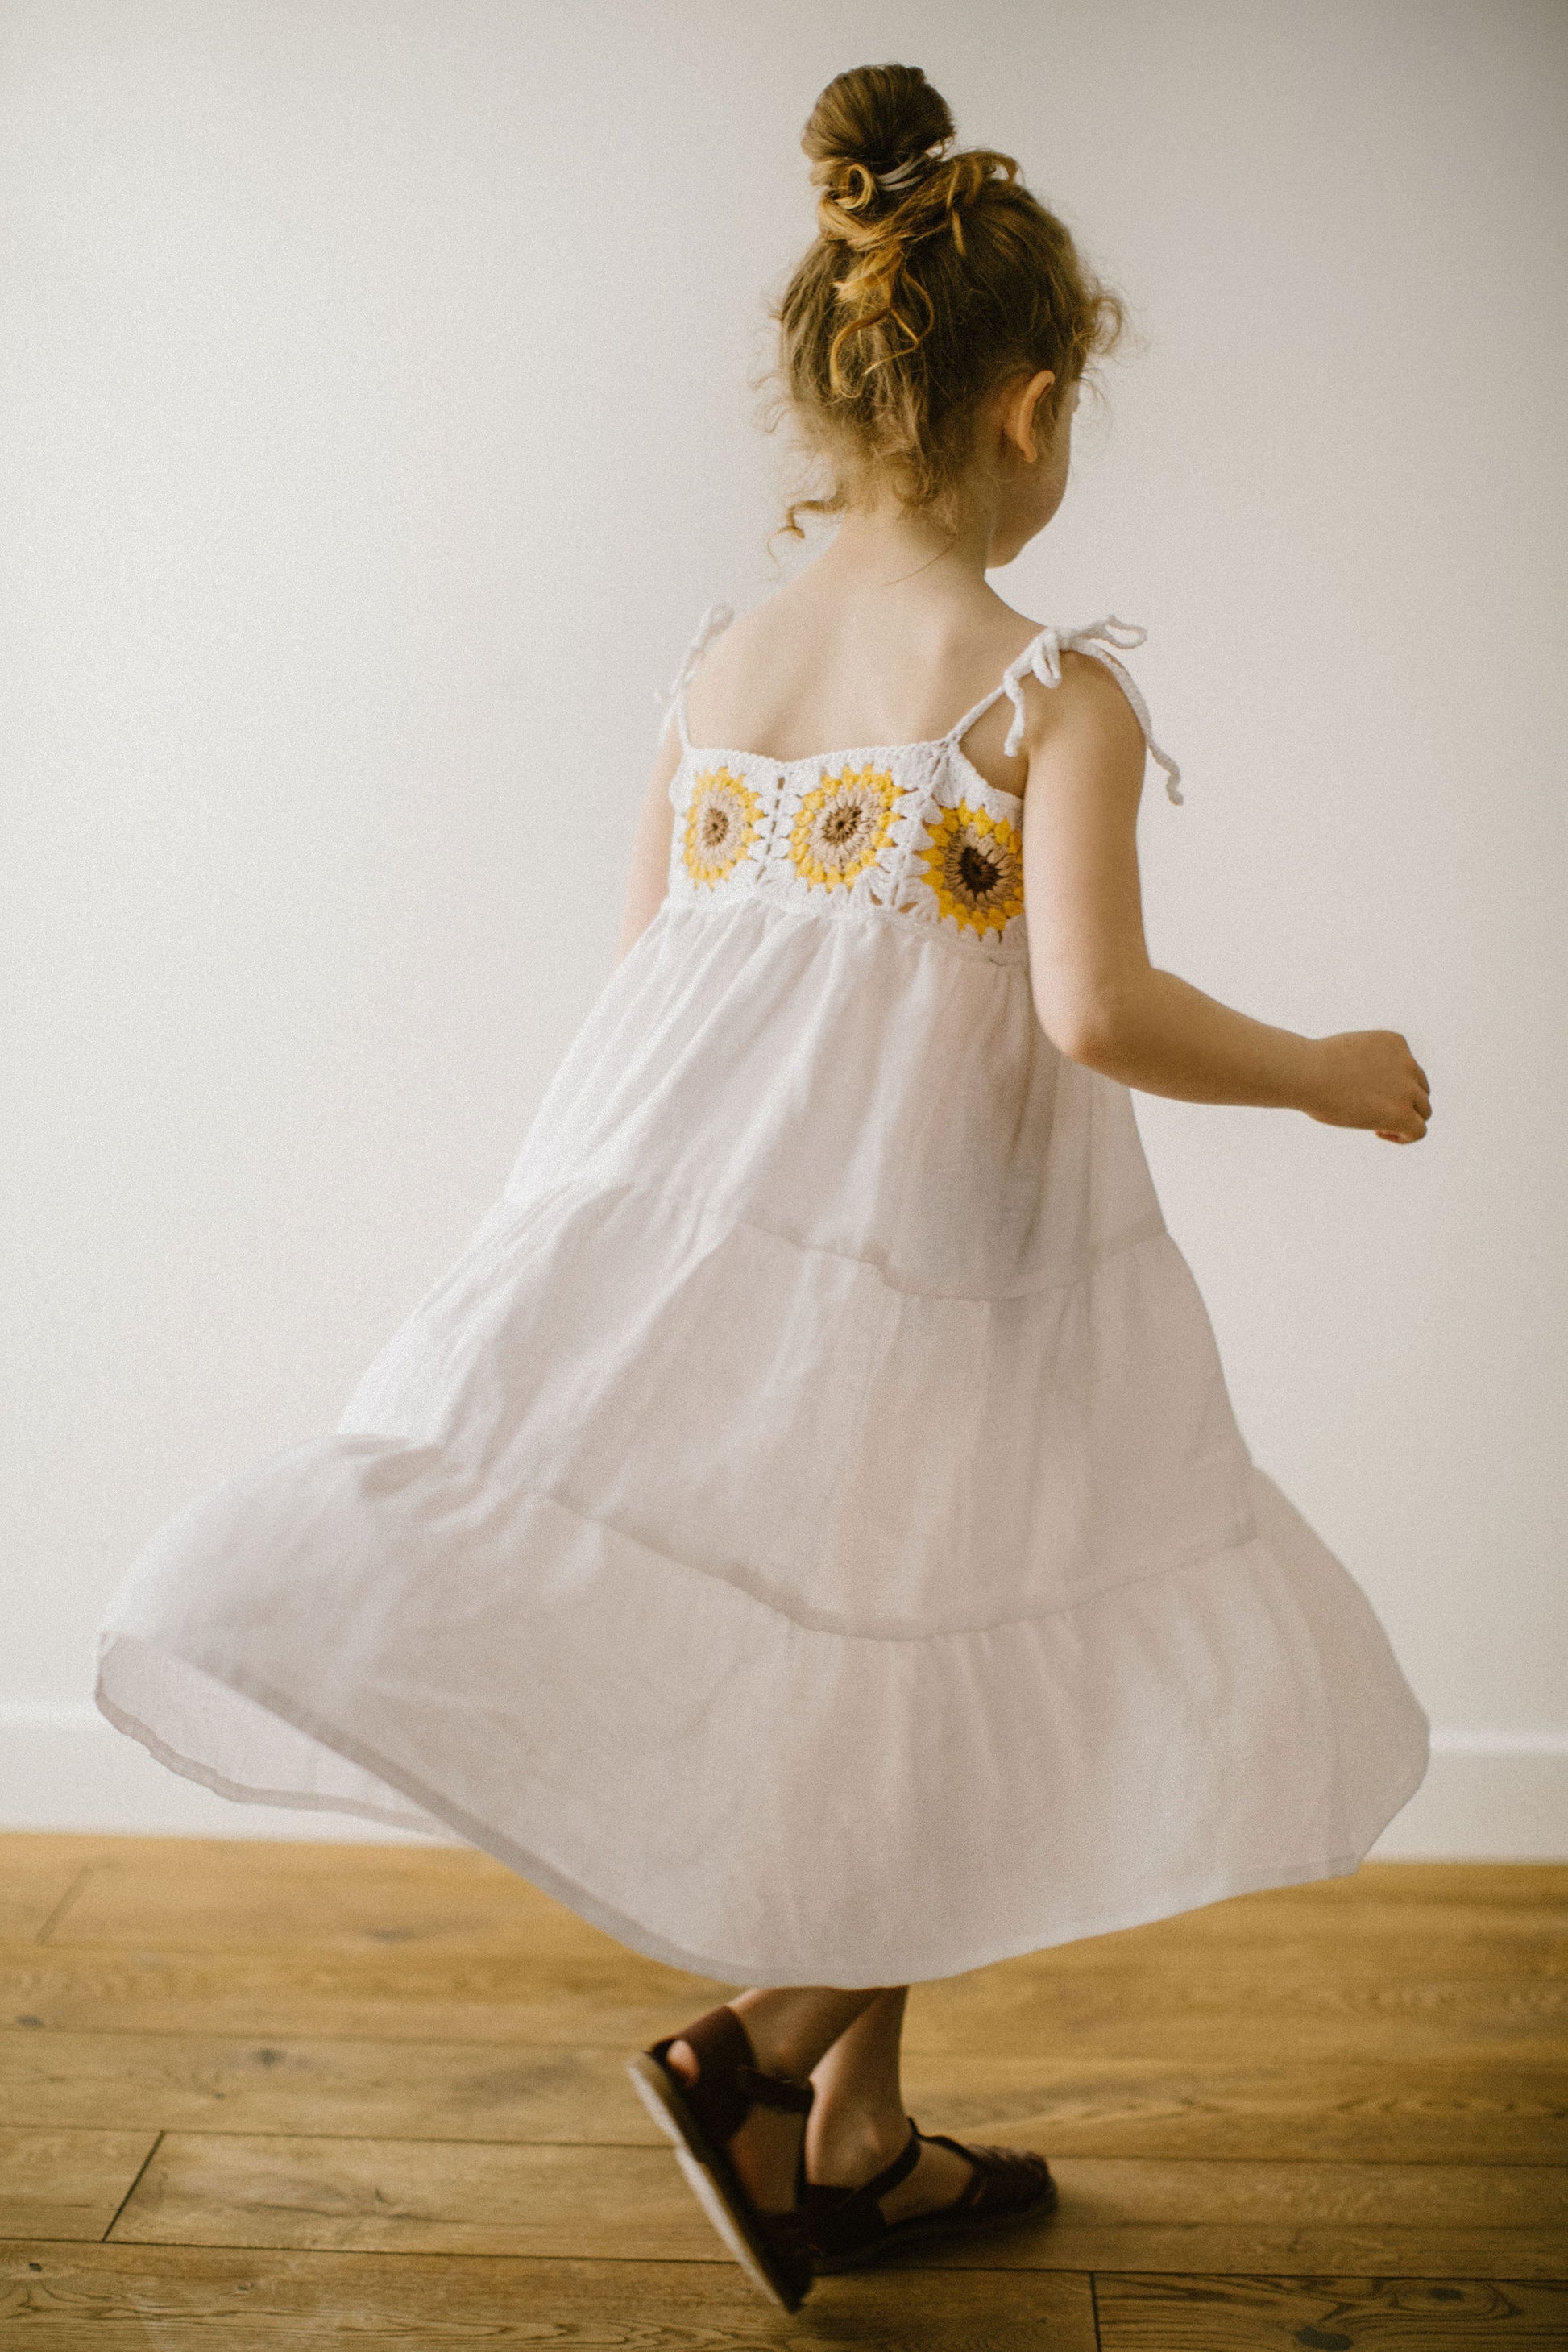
left=1023, top=653, right=1432, bottom=1143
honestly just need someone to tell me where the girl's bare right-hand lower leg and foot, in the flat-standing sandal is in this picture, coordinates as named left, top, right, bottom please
left=807, top=1985, right=973, bottom=2221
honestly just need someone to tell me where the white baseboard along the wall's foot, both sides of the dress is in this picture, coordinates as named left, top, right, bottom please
left=0, top=1703, right=1568, bottom=1863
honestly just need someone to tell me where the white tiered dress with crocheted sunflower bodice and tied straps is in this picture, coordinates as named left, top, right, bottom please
left=99, top=607, right=1427, bottom=1985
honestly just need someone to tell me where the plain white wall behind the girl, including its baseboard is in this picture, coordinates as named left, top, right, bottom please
left=0, top=0, right=1568, bottom=1853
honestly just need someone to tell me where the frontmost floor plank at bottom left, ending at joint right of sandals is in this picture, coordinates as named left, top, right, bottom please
left=0, top=2244, right=1096, bottom=2352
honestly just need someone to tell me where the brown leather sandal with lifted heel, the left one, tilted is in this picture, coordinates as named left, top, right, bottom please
left=625, top=2006, right=813, bottom=2312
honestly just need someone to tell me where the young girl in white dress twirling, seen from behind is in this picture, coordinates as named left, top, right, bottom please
left=99, top=66, right=1432, bottom=2309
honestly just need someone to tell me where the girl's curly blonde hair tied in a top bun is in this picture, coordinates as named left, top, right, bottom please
left=769, top=66, right=1126, bottom=538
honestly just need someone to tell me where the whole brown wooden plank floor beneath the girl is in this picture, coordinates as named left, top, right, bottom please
left=0, top=1837, right=1568, bottom=2352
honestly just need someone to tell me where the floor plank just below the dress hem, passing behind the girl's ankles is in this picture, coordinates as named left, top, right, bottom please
left=0, top=1943, right=1568, bottom=2068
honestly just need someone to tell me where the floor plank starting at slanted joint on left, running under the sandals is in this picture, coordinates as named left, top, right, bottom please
left=113, top=2134, right=1568, bottom=2277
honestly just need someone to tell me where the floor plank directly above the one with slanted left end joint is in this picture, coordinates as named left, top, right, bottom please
left=0, top=2030, right=1568, bottom=2163
